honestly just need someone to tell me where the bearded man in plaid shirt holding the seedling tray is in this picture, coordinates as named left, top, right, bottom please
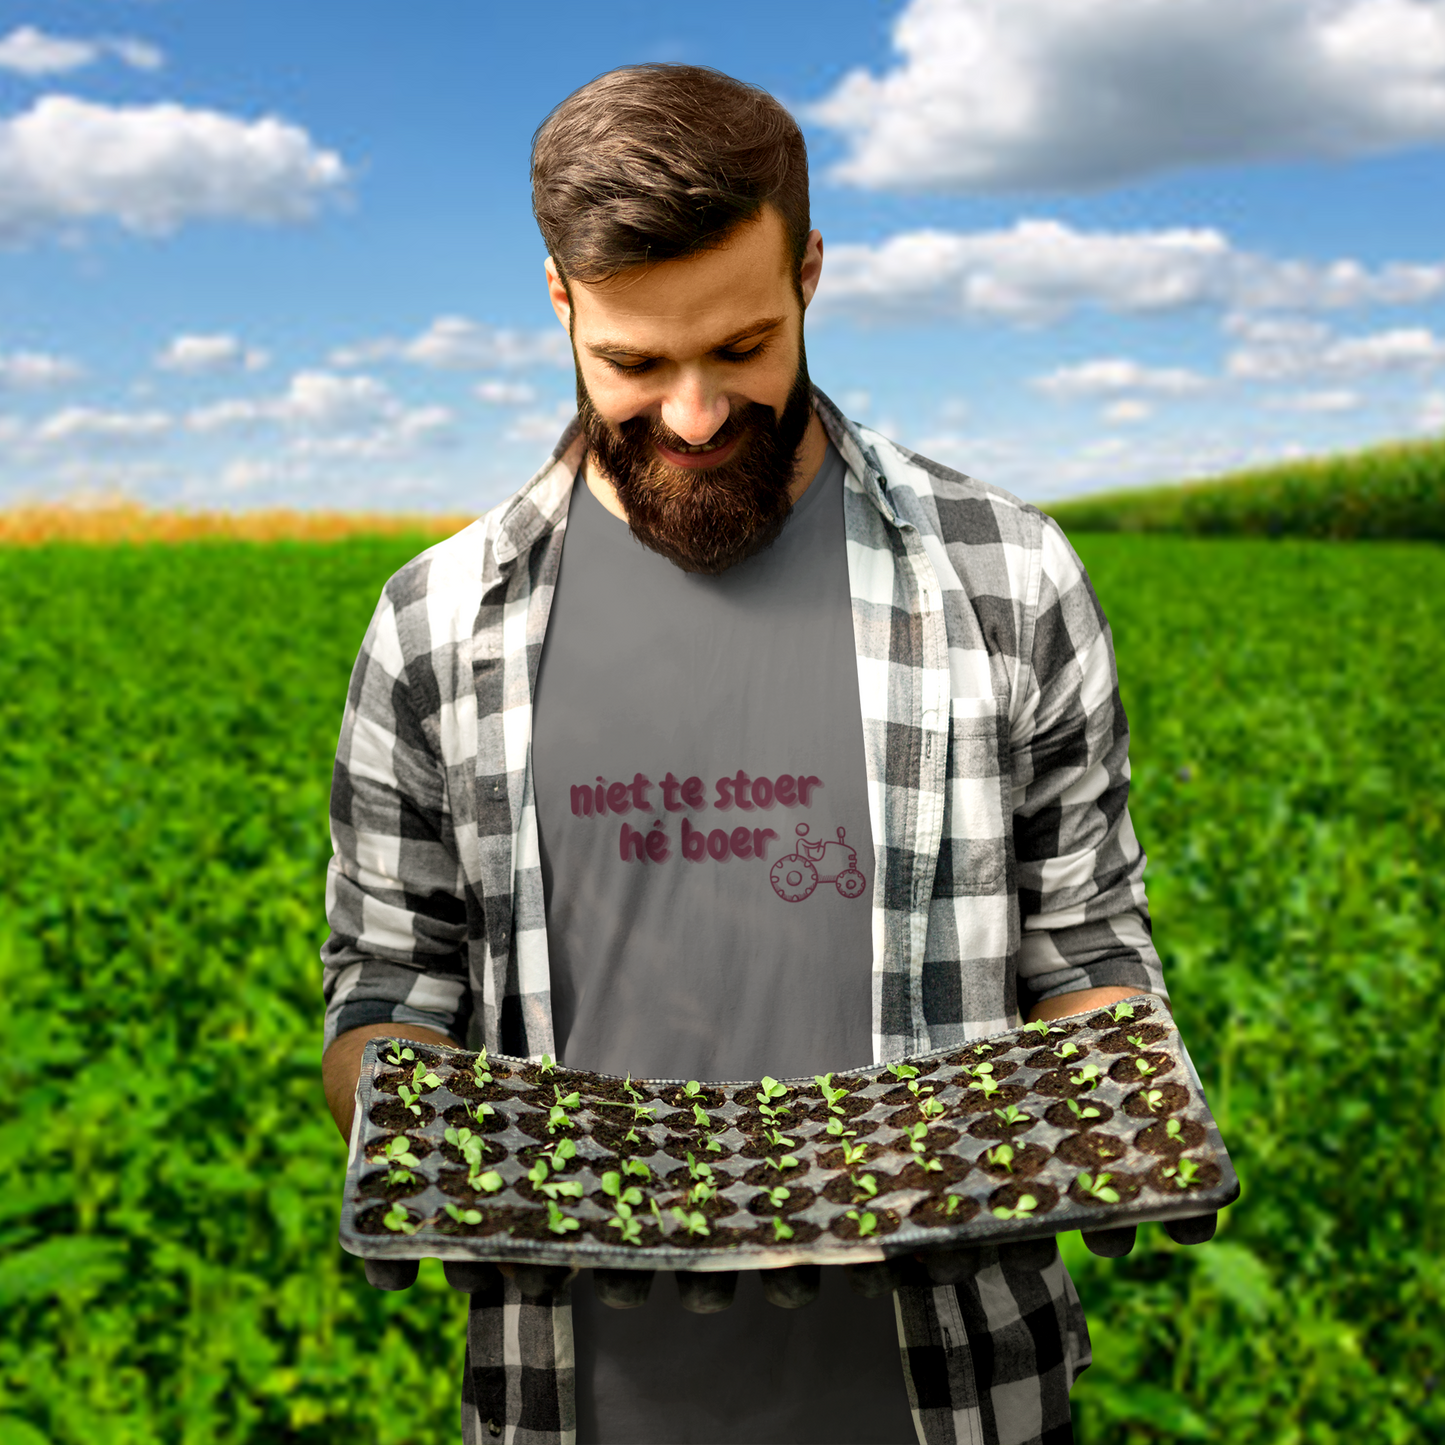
left=322, top=65, right=1166, bottom=1445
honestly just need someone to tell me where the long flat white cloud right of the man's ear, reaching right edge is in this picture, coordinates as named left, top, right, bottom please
left=814, top=218, right=1445, bottom=325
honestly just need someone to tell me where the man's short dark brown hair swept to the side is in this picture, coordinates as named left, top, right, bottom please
left=532, top=64, right=809, bottom=288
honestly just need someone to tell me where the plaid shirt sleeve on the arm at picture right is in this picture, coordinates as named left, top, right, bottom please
left=1010, top=517, right=1169, bottom=1017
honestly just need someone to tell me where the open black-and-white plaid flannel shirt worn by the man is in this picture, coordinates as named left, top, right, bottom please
left=322, top=393, right=1168, bottom=1445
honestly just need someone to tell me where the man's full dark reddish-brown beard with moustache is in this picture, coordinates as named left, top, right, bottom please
left=577, top=338, right=812, bottom=575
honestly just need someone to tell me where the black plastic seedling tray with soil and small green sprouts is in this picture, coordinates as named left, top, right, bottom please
left=341, top=996, right=1240, bottom=1272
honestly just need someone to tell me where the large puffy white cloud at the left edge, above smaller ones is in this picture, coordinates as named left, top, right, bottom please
left=0, top=95, right=347, bottom=244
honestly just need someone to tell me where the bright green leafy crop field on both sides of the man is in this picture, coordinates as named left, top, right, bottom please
left=0, top=535, right=1445, bottom=1445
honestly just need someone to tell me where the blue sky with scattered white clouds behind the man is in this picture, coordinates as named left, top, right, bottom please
left=0, top=0, right=1445, bottom=513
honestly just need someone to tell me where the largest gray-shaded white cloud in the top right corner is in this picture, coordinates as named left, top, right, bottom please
left=809, top=0, right=1445, bottom=192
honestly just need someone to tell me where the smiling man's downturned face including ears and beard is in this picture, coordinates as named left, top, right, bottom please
left=549, top=208, right=821, bottom=572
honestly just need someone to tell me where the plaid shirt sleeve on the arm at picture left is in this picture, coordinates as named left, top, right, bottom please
left=321, top=584, right=471, bottom=1045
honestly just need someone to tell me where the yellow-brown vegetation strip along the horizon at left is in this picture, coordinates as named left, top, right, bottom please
left=0, top=501, right=477, bottom=546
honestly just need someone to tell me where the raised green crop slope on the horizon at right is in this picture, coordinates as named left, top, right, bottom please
left=1043, top=438, right=1445, bottom=542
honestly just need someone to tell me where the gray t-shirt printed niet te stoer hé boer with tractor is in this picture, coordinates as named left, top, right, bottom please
left=532, top=447, right=913, bottom=1445
